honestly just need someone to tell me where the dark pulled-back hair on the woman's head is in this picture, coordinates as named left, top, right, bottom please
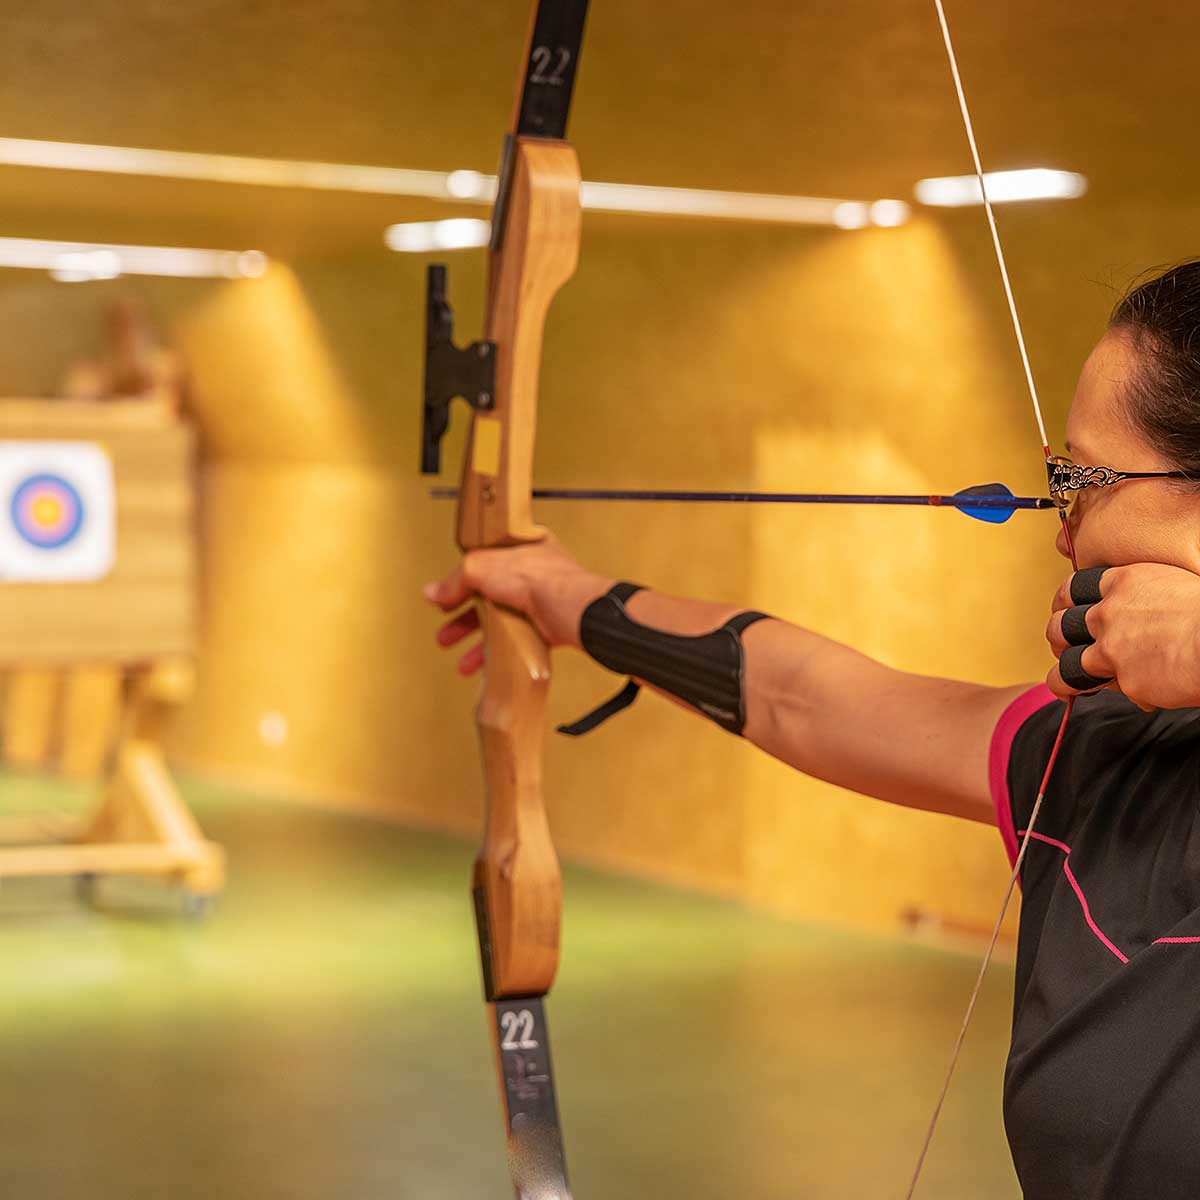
left=1109, top=259, right=1200, bottom=470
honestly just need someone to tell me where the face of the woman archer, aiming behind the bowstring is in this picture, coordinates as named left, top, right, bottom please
left=1057, top=331, right=1200, bottom=571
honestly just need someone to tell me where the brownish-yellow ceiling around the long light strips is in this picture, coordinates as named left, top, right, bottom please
left=0, top=0, right=1200, bottom=256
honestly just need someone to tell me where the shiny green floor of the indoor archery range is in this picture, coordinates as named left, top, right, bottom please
left=0, top=779, right=1018, bottom=1200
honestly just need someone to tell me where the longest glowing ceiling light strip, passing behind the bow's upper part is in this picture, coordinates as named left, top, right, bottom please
left=0, top=138, right=907, bottom=229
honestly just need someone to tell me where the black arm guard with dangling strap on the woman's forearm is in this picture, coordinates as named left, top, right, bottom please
left=558, top=583, right=767, bottom=737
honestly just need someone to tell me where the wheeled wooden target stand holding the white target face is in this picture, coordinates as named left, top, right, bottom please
left=0, top=310, right=224, bottom=913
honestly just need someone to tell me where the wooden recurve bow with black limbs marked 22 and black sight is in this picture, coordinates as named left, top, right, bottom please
left=421, top=0, right=587, bottom=1200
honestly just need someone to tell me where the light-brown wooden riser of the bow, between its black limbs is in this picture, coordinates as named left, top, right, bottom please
left=458, top=138, right=580, bottom=1000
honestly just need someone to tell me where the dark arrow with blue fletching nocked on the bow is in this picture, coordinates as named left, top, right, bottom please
left=430, top=484, right=1057, bottom=524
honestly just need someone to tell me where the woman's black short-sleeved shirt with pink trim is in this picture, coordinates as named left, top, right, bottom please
left=991, top=688, right=1200, bottom=1200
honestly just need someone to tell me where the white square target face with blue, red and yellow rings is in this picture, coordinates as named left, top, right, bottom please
left=0, top=442, right=116, bottom=583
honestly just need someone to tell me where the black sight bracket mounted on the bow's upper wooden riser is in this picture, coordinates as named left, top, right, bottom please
left=421, top=263, right=496, bottom=475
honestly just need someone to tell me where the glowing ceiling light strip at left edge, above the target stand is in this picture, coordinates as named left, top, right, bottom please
left=0, top=238, right=266, bottom=283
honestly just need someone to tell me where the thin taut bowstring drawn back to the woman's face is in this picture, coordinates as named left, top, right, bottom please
left=905, top=0, right=1079, bottom=1200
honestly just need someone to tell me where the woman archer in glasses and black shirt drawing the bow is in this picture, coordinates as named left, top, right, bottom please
left=426, top=262, right=1200, bottom=1200
